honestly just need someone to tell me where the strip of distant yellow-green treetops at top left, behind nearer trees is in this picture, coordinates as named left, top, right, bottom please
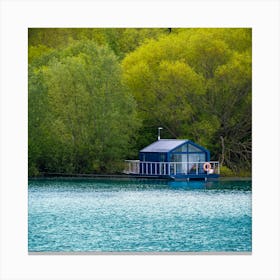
left=28, top=28, right=170, bottom=60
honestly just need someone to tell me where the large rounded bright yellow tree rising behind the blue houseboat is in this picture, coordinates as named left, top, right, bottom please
left=122, top=29, right=251, bottom=172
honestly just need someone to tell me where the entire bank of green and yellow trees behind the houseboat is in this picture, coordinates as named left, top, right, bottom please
left=28, top=28, right=252, bottom=176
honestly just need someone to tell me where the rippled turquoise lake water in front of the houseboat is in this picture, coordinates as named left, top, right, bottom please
left=28, top=179, right=252, bottom=252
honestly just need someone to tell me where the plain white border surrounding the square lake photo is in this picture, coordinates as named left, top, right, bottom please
left=0, top=0, right=280, bottom=280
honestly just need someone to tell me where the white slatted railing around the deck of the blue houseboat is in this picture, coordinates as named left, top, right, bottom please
left=124, top=160, right=220, bottom=176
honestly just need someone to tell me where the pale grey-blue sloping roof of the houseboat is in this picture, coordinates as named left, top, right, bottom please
left=140, top=139, right=189, bottom=153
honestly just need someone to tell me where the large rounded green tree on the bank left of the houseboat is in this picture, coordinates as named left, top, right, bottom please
left=29, top=41, right=138, bottom=173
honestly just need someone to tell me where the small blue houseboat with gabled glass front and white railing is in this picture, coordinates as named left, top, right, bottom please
left=124, top=139, right=220, bottom=180
